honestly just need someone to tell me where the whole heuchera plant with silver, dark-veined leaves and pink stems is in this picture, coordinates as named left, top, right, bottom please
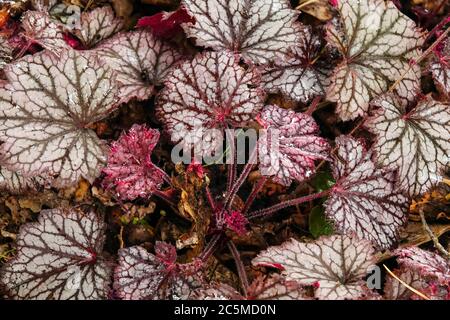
left=0, top=0, right=450, bottom=300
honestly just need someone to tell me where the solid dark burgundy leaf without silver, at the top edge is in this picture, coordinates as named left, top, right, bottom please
left=136, top=6, right=195, bottom=39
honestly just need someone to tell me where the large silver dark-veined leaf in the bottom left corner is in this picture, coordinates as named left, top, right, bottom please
left=0, top=209, right=111, bottom=300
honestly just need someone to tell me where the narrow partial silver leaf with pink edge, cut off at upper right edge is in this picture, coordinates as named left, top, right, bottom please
left=430, top=39, right=450, bottom=97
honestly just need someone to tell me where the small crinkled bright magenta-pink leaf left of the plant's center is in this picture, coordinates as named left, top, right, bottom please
left=103, top=124, right=164, bottom=200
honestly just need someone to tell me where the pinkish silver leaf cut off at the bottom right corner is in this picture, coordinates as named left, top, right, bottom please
left=394, top=247, right=450, bottom=286
